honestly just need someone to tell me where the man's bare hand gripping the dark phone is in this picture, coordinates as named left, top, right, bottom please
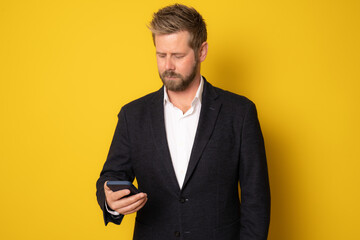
left=104, top=182, right=147, bottom=215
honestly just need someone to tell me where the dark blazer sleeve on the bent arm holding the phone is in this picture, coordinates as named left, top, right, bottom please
left=96, top=108, right=135, bottom=225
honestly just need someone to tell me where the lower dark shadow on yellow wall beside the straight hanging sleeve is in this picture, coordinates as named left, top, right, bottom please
left=262, top=129, right=304, bottom=240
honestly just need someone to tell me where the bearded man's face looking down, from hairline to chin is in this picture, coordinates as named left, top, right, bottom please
left=155, top=31, right=200, bottom=92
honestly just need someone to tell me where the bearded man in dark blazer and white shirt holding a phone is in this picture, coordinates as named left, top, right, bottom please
left=97, top=4, right=270, bottom=240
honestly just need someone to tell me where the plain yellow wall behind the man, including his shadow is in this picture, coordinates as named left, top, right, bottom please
left=0, top=0, right=360, bottom=240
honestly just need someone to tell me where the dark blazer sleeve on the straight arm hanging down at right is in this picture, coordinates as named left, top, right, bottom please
left=239, top=103, right=270, bottom=240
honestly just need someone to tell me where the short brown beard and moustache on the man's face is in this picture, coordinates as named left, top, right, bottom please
left=159, top=62, right=199, bottom=92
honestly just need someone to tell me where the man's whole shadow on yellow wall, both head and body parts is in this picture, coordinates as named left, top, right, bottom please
left=211, top=44, right=301, bottom=240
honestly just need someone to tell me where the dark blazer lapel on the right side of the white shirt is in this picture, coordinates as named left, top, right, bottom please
left=182, top=78, right=221, bottom=189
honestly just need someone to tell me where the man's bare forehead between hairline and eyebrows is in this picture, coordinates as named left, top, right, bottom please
left=155, top=31, right=190, bottom=52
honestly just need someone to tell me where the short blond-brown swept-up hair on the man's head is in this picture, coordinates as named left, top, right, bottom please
left=149, top=4, right=207, bottom=52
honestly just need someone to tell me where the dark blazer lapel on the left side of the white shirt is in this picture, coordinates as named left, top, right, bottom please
left=150, top=87, right=180, bottom=192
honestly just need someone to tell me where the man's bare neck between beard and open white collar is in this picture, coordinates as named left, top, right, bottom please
left=167, top=73, right=201, bottom=113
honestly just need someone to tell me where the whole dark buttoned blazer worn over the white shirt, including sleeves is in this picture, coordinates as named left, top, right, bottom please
left=97, top=80, right=270, bottom=240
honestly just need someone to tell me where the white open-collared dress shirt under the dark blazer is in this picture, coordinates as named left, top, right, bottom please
left=164, top=77, right=204, bottom=188
